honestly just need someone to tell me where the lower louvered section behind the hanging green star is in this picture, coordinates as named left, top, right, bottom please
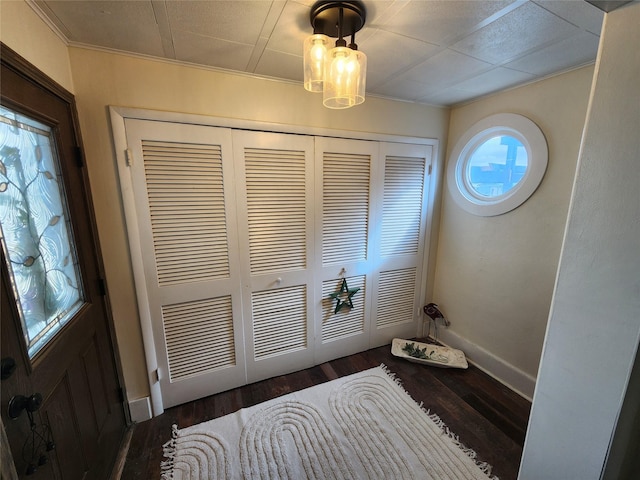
left=322, top=275, right=365, bottom=343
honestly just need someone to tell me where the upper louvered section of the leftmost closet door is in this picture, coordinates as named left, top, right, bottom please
left=142, top=140, right=229, bottom=286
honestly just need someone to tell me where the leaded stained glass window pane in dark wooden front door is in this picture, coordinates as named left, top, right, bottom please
left=0, top=107, right=84, bottom=358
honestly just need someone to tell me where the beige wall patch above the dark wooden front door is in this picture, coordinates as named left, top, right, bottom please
left=0, top=0, right=73, bottom=93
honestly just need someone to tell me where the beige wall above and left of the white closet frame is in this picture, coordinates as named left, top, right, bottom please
left=69, top=48, right=449, bottom=400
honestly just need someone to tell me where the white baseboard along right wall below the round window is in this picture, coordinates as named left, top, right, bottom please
left=438, top=328, right=536, bottom=401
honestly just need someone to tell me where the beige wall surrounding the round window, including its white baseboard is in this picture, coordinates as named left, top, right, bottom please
left=433, top=67, right=593, bottom=396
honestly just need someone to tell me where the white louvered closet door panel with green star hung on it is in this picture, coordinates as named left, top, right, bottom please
left=315, top=137, right=379, bottom=363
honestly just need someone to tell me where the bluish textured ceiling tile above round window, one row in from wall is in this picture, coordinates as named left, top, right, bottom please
left=452, top=2, right=579, bottom=64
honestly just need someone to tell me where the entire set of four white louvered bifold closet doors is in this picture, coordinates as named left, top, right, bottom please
left=121, top=114, right=433, bottom=408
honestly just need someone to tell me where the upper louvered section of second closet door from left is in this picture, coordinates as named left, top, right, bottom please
left=244, top=148, right=307, bottom=275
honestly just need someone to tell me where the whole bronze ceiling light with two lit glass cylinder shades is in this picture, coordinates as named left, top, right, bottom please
left=304, top=1, right=367, bottom=108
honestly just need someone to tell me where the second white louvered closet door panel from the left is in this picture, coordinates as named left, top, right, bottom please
left=233, top=131, right=314, bottom=382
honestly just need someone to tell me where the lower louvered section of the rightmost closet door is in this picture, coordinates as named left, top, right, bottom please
left=376, top=267, right=416, bottom=328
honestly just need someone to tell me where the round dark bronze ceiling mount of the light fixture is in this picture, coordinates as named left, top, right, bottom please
left=310, top=1, right=367, bottom=38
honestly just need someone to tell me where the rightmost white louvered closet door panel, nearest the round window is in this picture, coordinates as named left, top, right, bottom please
left=370, top=143, right=433, bottom=348
